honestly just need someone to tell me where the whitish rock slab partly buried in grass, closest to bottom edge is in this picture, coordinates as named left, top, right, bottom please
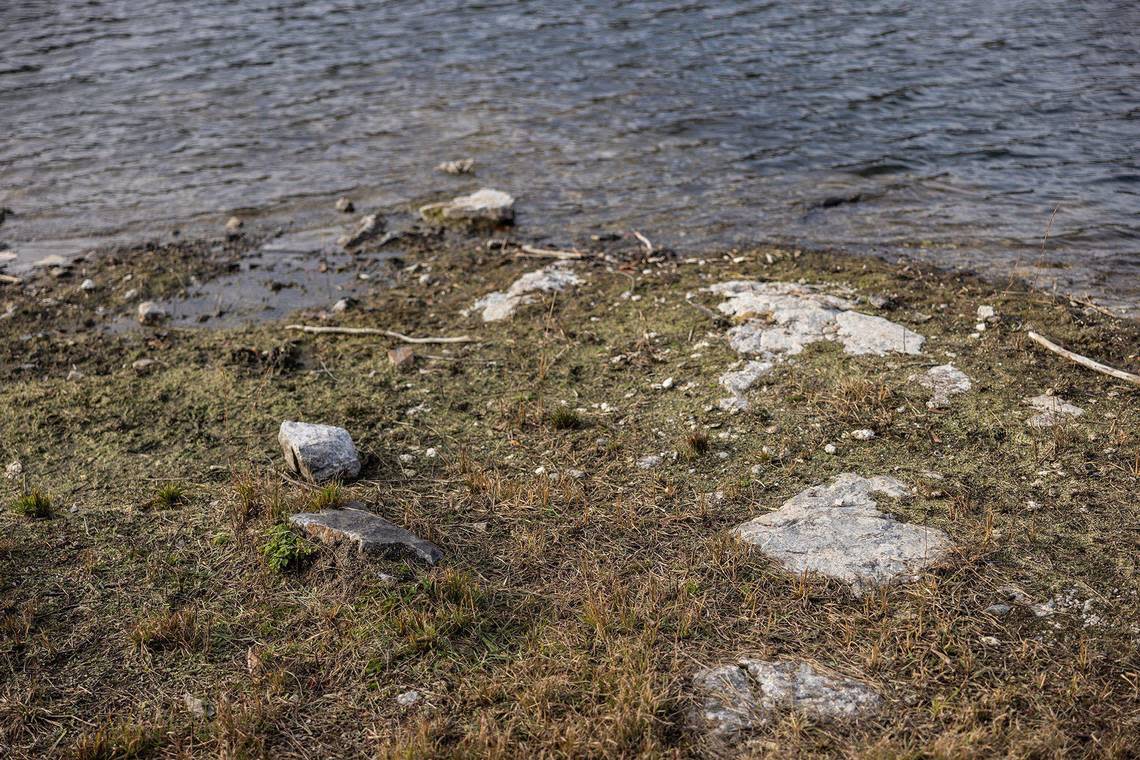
left=692, top=659, right=882, bottom=738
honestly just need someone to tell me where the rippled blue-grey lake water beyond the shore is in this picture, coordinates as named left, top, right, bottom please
left=0, top=0, right=1140, bottom=312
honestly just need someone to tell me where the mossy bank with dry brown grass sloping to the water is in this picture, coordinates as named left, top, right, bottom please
left=0, top=234, right=1140, bottom=758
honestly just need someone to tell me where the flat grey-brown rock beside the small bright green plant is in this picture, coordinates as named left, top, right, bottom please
left=288, top=501, right=443, bottom=565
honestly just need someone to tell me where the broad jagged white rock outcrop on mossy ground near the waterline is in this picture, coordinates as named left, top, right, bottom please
left=708, top=280, right=926, bottom=362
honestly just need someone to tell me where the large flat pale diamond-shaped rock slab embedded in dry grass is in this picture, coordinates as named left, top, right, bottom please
left=735, top=473, right=950, bottom=593
